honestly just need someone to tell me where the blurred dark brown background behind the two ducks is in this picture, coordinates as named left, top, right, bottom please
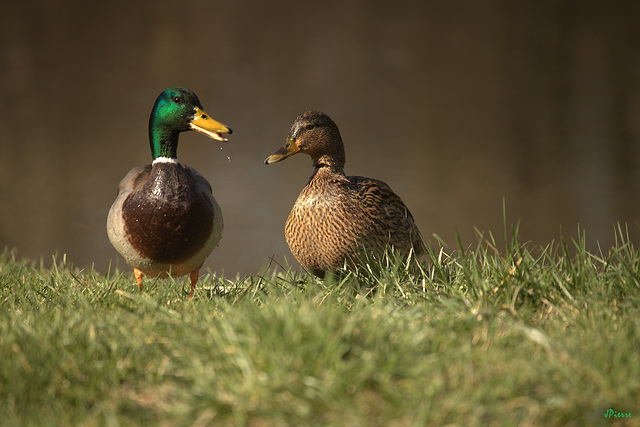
left=0, top=0, right=640, bottom=276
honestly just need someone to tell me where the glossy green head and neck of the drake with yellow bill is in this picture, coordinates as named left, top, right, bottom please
left=149, top=87, right=232, bottom=160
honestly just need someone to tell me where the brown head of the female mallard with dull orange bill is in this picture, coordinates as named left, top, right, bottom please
left=264, top=110, right=345, bottom=169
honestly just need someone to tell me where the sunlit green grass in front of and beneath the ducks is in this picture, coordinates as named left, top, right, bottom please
left=0, top=227, right=640, bottom=426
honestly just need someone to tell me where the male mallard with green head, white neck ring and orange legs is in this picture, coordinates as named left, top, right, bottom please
left=107, top=87, right=232, bottom=299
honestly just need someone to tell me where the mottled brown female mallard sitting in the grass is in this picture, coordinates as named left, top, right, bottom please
left=265, top=111, right=424, bottom=277
